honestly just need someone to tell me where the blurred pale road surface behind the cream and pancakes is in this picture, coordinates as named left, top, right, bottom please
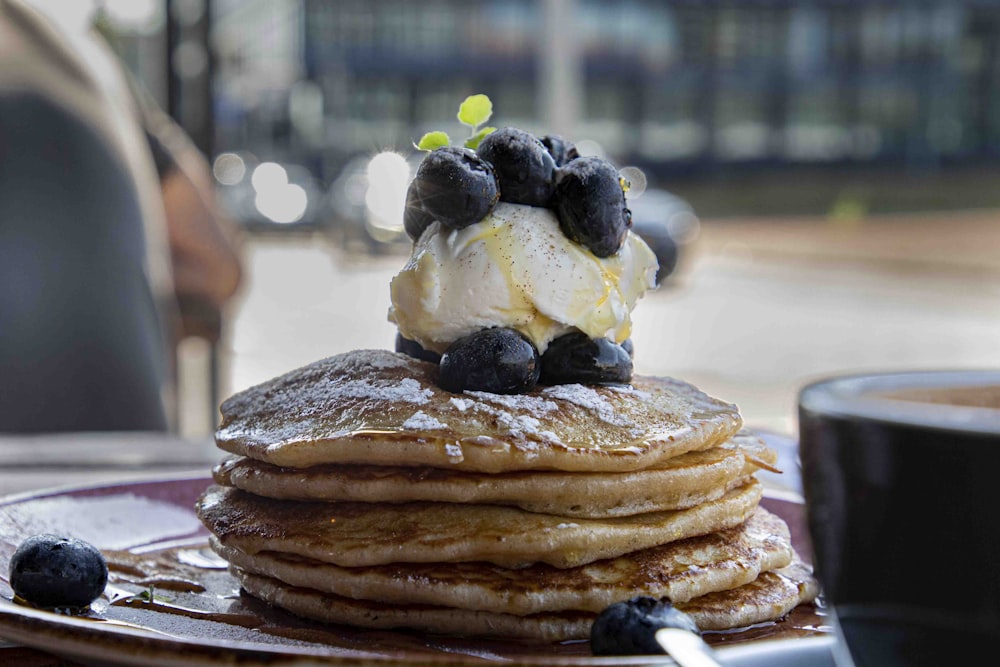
left=193, top=211, right=1000, bottom=434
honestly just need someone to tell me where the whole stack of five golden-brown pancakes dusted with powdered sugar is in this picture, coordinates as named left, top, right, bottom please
left=197, top=350, right=817, bottom=640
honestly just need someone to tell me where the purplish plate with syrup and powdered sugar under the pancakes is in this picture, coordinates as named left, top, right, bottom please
left=0, top=475, right=833, bottom=667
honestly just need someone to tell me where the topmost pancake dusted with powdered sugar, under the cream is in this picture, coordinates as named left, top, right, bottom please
left=216, top=350, right=742, bottom=472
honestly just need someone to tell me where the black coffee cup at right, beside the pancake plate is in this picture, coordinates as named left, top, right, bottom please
left=799, top=370, right=1000, bottom=667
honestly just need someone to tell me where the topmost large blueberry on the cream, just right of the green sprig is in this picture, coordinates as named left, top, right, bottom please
left=476, top=127, right=556, bottom=206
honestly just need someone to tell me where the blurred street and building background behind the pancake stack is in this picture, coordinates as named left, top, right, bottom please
left=99, top=0, right=1000, bottom=435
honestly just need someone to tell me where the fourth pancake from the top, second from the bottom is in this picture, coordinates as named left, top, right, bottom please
left=211, top=508, right=793, bottom=615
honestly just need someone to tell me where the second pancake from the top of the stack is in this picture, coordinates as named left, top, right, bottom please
left=213, top=433, right=777, bottom=518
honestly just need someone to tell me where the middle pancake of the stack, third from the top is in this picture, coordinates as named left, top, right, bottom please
left=196, top=480, right=762, bottom=568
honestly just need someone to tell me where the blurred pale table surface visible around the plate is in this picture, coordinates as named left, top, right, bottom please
left=0, top=432, right=801, bottom=667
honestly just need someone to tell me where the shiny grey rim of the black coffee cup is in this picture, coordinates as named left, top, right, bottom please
left=798, top=369, right=1000, bottom=435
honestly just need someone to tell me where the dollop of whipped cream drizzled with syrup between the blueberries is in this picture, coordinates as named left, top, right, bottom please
left=389, top=202, right=657, bottom=353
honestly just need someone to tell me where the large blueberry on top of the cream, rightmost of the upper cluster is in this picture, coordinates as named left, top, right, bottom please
left=553, top=157, right=632, bottom=257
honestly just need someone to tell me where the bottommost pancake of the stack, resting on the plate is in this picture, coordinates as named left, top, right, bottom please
left=230, top=552, right=816, bottom=641
